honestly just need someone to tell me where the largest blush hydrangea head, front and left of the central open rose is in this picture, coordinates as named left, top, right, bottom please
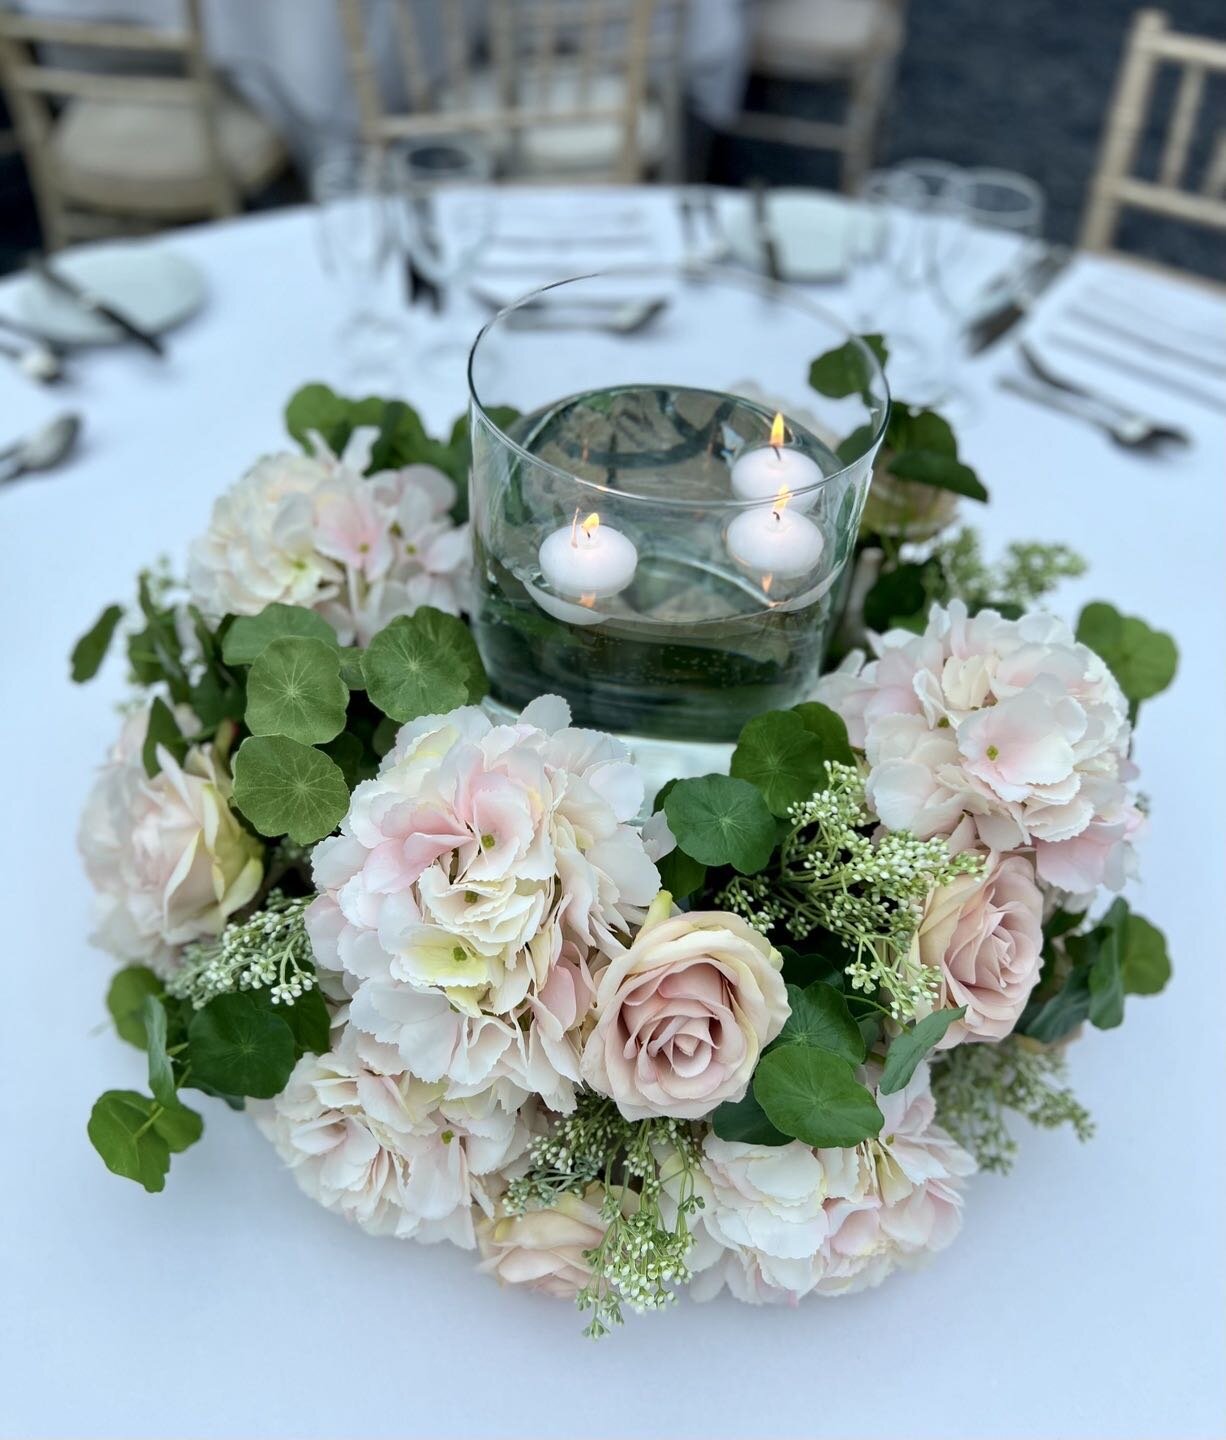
left=307, top=697, right=660, bottom=1110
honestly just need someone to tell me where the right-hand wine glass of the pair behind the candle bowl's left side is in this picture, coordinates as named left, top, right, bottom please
left=390, top=135, right=494, bottom=379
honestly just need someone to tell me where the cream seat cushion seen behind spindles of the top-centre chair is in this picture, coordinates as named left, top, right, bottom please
left=441, top=60, right=666, bottom=177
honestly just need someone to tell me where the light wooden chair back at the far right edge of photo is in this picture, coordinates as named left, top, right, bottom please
left=1080, top=10, right=1226, bottom=251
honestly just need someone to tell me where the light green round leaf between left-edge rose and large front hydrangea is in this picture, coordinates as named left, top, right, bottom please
left=233, top=734, right=349, bottom=845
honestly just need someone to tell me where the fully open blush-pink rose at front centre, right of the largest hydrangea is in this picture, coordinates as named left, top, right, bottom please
left=581, top=891, right=788, bottom=1120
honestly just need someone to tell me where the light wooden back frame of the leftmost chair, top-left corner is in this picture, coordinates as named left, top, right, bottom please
left=0, top=0, right=239, bottom=249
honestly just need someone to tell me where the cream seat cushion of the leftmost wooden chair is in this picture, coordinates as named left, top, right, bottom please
left=52, top=95, right=285, bottom=216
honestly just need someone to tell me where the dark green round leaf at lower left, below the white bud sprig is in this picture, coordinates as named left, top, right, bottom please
left=187, top=991, right=294, bottom=1100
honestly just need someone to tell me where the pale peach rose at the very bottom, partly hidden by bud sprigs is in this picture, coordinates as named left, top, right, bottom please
left=477, top=1185, right=608, bottom=1300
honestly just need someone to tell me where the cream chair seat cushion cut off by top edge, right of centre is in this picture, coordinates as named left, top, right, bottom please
left=753, top=0, right=902, bottom=79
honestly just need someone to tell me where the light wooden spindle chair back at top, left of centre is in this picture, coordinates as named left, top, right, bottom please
left=340, top=0, right=684, bottom=180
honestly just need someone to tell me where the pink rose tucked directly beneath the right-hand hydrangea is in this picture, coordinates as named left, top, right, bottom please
left=912, top=855, right=1043, bottom=1050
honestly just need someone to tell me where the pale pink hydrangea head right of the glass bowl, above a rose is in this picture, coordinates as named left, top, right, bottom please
left=817, top=600, right=1142, bottom=894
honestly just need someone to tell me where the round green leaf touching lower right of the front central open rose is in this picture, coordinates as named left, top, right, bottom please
left=753, top=1045, right=885, bottom=1149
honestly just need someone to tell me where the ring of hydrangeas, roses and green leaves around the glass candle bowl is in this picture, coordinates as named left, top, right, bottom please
left=72, top=357, right=1174, bottom=1335
